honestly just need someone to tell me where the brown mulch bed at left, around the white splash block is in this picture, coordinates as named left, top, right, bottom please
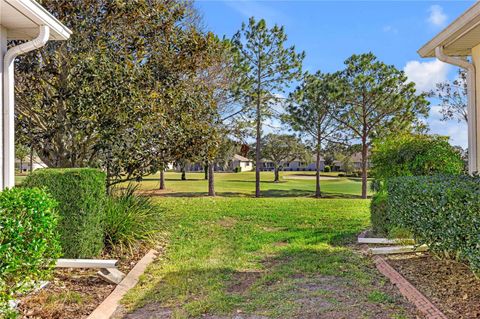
left=18, top=246, right=148, bottom=319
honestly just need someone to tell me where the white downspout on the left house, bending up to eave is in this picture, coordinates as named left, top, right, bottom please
left=0, top=26, right=50, bottom=189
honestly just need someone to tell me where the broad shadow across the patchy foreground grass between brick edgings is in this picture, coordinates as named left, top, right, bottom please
left=124, top=243, right=405, bottom=319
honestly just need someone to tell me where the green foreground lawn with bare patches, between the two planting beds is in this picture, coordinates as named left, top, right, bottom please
left=124, top=199, right=411, bottom=319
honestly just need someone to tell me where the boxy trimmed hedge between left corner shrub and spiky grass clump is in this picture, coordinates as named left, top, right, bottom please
left=23, top=168, right=106, bottom=258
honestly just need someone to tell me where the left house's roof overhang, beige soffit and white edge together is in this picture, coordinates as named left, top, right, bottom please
left=0, top=0, right=72, bottom=40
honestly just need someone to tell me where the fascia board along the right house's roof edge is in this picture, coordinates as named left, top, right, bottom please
left=417, top=2, right=480, bottom=58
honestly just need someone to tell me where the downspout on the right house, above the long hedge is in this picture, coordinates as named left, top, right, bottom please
left=435, top=46, right=479, bottom=174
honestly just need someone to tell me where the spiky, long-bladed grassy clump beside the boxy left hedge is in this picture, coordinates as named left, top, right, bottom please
left=103, top=185, right=160, bottom=255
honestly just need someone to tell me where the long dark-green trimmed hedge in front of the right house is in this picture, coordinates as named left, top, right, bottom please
left=387, top=175, right=480, bottom=272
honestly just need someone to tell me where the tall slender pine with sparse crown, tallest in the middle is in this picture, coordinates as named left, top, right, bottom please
left=232, top=17, right=305, bottom=197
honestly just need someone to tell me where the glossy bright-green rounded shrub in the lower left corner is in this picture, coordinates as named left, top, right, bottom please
left=0, top=188, right=61, bottom=317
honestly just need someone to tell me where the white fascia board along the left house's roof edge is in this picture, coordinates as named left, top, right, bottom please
left=3, top=0, right=72, bottom=40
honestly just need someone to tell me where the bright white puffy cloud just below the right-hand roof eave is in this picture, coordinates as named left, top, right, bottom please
left=403, top=60, right=450, bottom=92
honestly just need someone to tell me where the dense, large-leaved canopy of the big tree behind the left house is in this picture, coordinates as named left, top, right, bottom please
left=16, top=0, right=219, bottom=183
